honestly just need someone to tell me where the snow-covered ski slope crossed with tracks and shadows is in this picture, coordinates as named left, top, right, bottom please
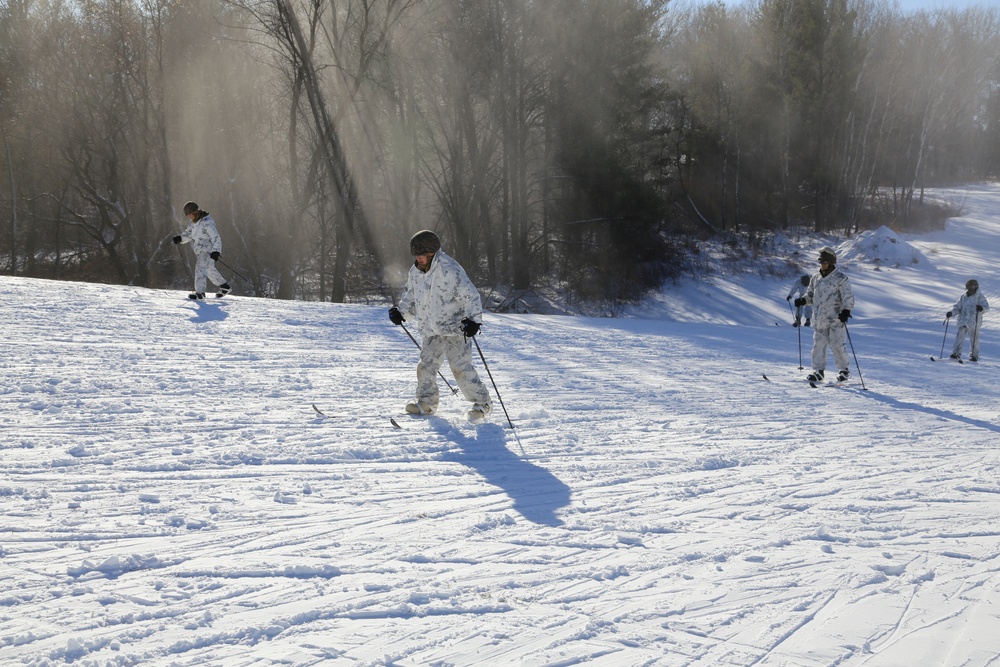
left=0, top=185, right=1000, bottom=667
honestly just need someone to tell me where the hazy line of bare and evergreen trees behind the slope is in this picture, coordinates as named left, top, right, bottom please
left=0, top=0, right=1000, bottom=308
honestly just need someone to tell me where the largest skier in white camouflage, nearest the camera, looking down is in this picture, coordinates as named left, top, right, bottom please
left=389, top=229, right=491, bottom=421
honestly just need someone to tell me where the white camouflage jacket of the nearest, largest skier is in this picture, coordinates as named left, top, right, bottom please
left=398, top=250, right=483, bottom=336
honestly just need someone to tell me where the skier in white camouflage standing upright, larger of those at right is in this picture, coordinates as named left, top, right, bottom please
left=795, top=247, right=854, bottom=382
